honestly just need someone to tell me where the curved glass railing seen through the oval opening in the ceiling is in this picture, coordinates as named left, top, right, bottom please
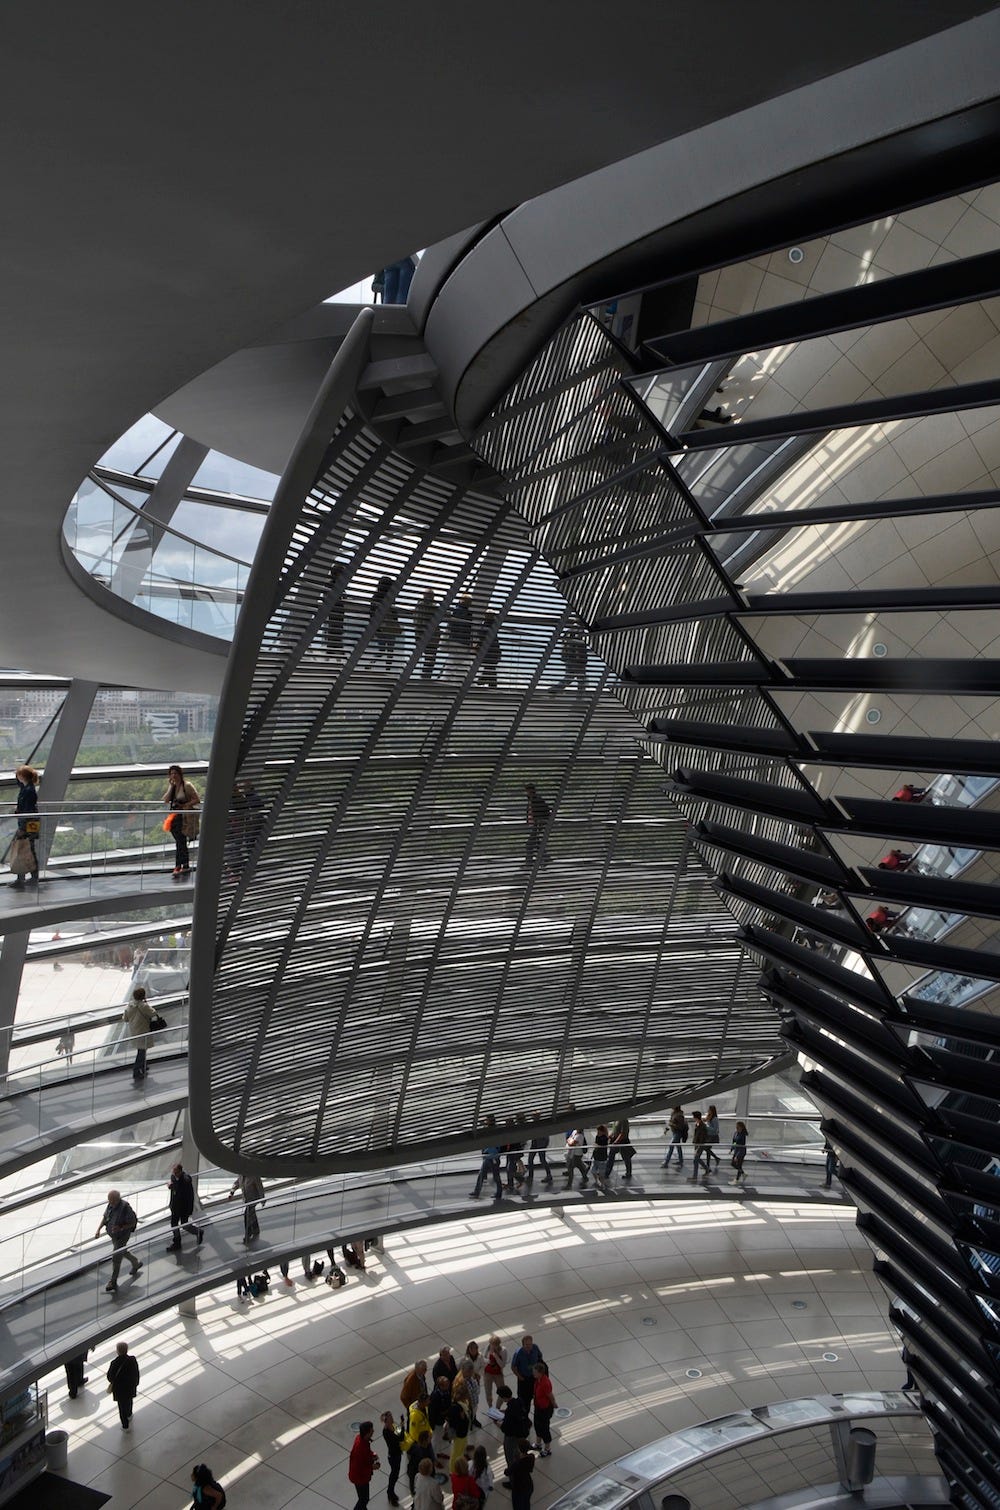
left=62, top=474, right=251, bottom=640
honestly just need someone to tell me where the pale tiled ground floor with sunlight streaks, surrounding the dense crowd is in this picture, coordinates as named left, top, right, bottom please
left=45, top=1202, right=902, bottom=1510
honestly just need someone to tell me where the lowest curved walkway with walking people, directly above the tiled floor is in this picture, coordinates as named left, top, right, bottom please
left=0, top=1161, right=847, bottom=1395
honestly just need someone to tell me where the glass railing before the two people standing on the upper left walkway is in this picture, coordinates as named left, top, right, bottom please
left=0, top=802, right=196, bottom=898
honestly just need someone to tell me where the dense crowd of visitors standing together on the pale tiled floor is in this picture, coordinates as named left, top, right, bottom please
left=347, top=1333, right=556, bottom=1510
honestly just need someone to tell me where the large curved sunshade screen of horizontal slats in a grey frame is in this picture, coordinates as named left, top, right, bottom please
left=192, top=312, right=779, bottom=1175
